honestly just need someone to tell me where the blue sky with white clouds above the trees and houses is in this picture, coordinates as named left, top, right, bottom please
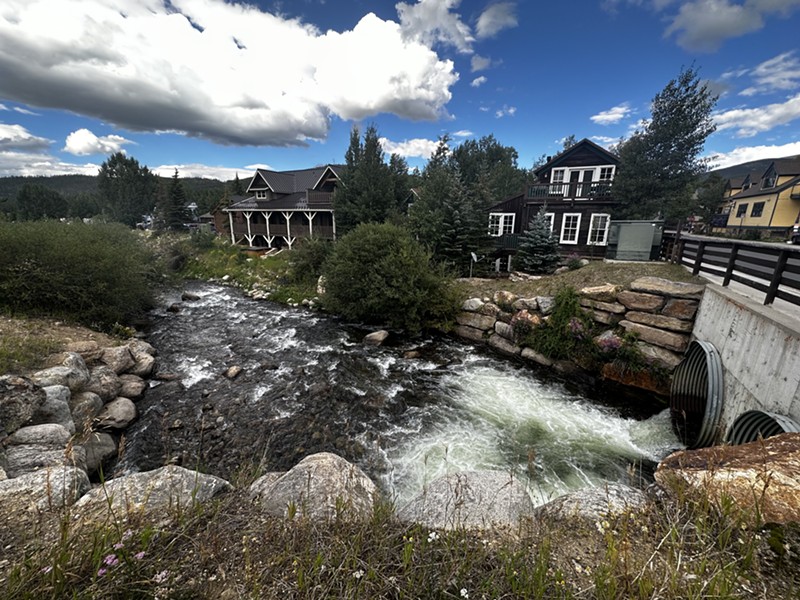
left=0, top=0, right=800, bottom=179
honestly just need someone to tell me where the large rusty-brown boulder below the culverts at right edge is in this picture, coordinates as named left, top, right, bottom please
left=655, top=433, right=800, bottom=524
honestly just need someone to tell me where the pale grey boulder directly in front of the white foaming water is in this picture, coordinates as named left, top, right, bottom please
left=397, top=471, right=533, bottom=529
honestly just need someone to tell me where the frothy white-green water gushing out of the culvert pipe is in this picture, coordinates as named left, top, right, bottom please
left=384, top=364, right=680, bottom=506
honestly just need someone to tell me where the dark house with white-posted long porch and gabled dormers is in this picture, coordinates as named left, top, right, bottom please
left=223, top=165, right=344, bottom=249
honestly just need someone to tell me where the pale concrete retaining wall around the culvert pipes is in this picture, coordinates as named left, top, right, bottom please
left=694, top=284, right=800, bottom=439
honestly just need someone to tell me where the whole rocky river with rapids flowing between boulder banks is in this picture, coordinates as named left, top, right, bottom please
left=116, top=283, right=680, bottom=506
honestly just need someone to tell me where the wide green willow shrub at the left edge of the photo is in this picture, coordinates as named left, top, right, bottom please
left=0, top=221, right=159, bottom=330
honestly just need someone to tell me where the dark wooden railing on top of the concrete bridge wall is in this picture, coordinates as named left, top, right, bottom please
left=661, top=232, right=800, bottom=306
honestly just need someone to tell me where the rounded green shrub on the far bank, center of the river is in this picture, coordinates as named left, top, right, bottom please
left=323, top=224, right=456, bottom=332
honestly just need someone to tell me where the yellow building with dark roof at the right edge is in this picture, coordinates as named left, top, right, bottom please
left=727, top=158, right=800, bottom=238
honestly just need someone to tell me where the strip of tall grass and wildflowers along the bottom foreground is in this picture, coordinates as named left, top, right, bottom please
left=0, top=482, right=800, bottom=600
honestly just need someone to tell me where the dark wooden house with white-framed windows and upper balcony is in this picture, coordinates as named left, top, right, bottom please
left=489, top=139, right=619, bottom=271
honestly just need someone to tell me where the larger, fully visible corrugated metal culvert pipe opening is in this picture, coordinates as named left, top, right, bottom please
left=669, top=340, right=723, bottom=448
